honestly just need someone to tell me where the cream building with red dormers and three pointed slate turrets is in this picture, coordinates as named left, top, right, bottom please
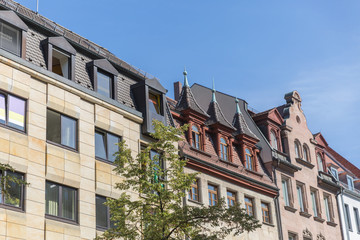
left=169, top=74, right=279, bottom=240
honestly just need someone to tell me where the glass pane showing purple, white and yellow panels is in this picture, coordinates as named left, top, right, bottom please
left=8, top=95, right=25, bottom=130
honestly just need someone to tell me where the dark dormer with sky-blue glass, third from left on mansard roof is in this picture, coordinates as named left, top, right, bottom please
left=87, top=59, right=119, bottom=100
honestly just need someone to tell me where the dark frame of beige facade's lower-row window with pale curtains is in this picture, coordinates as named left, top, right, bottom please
left=45, top=180, right=79, bottom=224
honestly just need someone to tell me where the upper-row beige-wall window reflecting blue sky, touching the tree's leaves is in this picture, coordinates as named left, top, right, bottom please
left=95, top=129, right=121, bottom=162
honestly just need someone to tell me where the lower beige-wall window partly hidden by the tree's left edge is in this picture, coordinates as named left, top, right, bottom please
left=96, top=195, right=114, bottom=230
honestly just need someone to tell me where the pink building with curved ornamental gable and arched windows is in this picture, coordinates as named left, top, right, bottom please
left=252, top=91, right=342, bottom=240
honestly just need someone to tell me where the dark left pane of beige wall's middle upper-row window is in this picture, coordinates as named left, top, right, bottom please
left=46, top=109, right=61, bottom=144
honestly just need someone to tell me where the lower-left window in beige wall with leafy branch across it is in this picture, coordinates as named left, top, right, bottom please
left=0, top=171, right=24, bottom=209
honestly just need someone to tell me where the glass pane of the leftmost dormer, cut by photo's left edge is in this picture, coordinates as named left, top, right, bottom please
left=1, top=23, right=20, bottom=56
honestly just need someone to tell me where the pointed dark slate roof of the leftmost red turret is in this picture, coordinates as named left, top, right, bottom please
left=175, top=85, right=209, bottom=117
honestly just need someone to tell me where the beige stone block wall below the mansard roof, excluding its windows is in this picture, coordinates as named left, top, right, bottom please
left=0, top=57, right=142, bottom=240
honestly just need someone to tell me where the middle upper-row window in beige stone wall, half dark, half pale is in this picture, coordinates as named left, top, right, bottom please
left=46, top=109, right=77, bottom=149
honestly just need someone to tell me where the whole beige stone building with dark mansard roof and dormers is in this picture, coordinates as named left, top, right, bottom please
left=0, top=0, right=171, bottom=240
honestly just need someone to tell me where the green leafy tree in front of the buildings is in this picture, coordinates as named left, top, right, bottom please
left=97, top=121, right=261, bottom=240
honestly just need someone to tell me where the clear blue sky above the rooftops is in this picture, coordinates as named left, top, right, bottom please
left=14, top=0, right=360, bottom=167
